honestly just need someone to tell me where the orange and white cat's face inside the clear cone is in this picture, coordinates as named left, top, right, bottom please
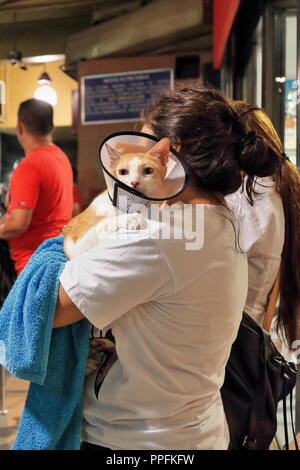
left=105, top=139, right=170, bottom=196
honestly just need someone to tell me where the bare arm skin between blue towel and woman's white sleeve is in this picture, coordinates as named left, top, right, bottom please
left=53, top=284, right=84, bottom=328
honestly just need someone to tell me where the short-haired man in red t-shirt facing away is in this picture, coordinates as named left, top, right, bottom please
left=0, top=99, right=73, bottom=274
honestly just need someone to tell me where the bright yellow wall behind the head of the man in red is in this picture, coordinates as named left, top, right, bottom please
left=0, top=61, right=78, bottom=131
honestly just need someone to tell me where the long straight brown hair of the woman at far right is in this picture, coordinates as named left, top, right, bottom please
left=233, top=101, right=300, bottom=346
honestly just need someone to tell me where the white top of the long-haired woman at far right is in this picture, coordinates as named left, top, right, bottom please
left=226, top=177, right=285, bottom=325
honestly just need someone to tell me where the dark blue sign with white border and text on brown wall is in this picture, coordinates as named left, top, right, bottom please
left=81, top=69, right=173, bottom=124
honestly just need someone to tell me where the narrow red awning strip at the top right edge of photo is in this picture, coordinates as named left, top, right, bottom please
left=213, top=0, right=240, bottom=69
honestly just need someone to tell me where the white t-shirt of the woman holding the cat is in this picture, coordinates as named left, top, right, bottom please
left=60, top=205, right=247, bottom=449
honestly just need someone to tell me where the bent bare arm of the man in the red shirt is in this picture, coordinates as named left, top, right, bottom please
left=0, top=209, right=33, bottom=240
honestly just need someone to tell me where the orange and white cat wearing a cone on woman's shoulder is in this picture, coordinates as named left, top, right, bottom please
left=62, top=138, right=170, bottom=258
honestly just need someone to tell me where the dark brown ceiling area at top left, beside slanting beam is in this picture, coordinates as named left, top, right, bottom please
left=0, top=0, right=149, bottom=60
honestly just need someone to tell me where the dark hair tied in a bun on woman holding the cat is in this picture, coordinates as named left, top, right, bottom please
left=142, top=88, right=278, bottom=198
